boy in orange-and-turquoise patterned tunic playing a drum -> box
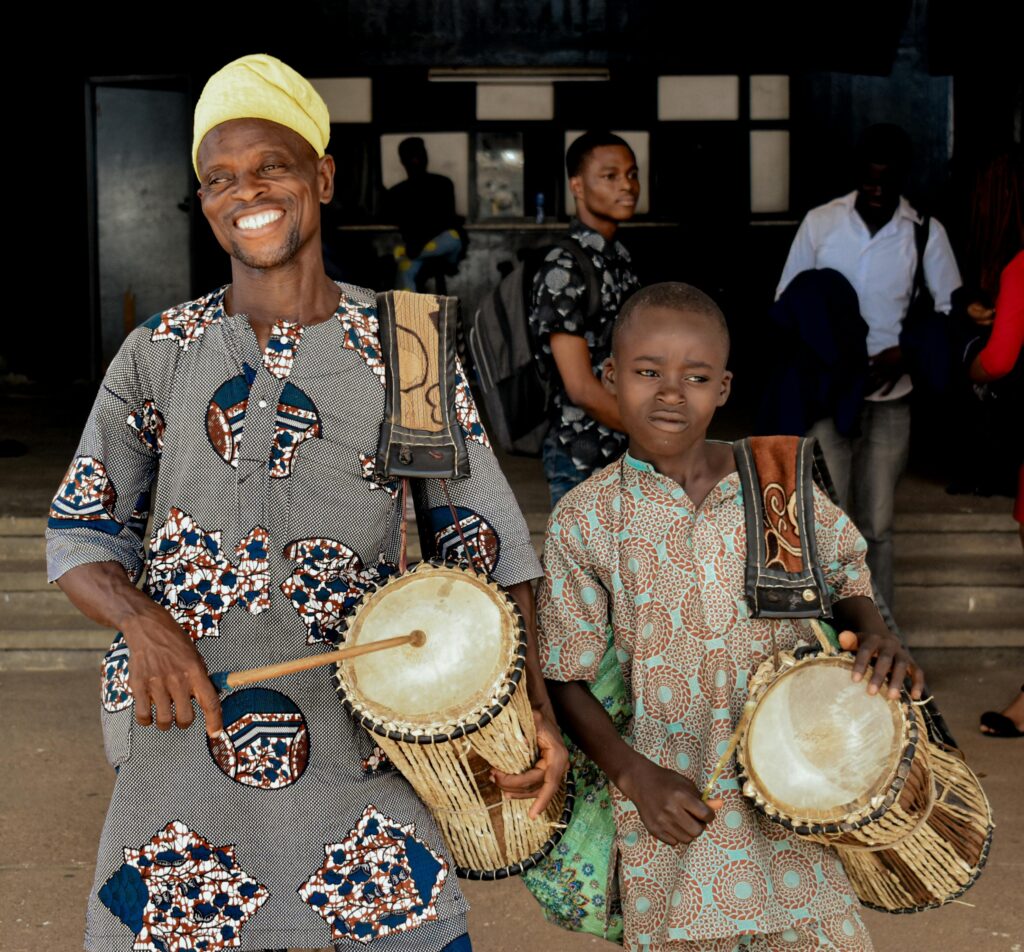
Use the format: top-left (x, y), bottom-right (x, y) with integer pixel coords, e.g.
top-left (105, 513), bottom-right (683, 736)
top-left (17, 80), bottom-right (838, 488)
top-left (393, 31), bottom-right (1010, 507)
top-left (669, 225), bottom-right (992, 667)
top-left (540, 284), bottom-right (924, 952)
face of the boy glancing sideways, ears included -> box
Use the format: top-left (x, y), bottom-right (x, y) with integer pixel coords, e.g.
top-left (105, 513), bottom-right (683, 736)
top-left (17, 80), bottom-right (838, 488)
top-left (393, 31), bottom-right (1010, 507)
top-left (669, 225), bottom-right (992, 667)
top-left (602, 307), bottom-right (732, 462)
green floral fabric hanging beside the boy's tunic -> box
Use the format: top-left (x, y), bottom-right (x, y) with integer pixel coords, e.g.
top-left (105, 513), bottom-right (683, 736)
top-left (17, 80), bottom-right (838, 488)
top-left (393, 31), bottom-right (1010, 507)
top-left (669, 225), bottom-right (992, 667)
top-left (523, 632), bottom-right (633, 944)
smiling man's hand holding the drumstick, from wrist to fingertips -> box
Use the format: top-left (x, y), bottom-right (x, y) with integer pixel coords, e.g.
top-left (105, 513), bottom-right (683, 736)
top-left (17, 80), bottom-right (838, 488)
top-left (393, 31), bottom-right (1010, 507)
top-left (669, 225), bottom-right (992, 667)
top-left (121, 602), bottom-right (223, 737)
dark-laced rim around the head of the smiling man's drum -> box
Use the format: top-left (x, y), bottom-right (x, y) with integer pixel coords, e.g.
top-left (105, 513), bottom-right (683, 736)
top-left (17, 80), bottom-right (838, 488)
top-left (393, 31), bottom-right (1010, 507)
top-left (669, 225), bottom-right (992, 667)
top-left (334, 559), bottom-right (527, 744)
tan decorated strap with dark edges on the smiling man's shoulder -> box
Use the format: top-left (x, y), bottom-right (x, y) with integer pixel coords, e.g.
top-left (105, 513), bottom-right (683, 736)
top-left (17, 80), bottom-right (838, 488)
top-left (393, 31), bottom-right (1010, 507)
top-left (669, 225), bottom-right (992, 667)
top-left (374, 291), bottom-right (469, 482)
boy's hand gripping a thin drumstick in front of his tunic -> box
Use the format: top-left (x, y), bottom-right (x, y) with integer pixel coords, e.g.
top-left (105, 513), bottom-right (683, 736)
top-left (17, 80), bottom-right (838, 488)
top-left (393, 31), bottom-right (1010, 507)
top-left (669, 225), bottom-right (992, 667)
top-left (620, 755), bottom-right (715, 847)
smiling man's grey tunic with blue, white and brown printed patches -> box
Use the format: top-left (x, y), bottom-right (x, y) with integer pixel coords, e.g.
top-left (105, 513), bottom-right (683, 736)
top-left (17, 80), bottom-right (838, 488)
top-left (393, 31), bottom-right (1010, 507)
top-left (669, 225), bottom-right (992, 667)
top-left (47, 286), bottom-right (540, 952)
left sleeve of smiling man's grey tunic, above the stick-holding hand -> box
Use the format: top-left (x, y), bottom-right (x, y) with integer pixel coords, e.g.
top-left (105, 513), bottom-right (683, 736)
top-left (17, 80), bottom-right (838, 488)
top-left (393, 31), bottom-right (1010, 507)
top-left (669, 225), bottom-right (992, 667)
top-left (46, 329), bottom-right (164, 581)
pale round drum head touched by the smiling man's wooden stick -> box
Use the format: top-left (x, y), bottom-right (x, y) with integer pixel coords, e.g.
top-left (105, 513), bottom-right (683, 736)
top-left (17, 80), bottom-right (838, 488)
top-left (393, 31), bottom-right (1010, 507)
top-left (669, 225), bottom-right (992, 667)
top-left (338, 564), bottom-right (519, 733)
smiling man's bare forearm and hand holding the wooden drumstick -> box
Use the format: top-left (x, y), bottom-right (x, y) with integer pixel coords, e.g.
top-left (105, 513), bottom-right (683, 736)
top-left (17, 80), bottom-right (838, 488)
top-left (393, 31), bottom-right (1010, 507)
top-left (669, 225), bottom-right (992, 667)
top-left (57, 562), bottom-right (223, 737)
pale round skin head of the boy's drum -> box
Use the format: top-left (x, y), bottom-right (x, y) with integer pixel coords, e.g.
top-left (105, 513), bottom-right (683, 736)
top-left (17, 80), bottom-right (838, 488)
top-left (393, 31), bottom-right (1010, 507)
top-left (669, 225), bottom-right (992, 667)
top-left (745, 658), bottom-right (903, 822)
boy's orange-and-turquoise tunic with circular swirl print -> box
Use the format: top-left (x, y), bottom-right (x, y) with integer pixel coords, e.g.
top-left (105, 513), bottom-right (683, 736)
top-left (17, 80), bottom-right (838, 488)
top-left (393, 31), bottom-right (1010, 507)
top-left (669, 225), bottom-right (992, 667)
top-left (539, 453), bottom-right (870, 949)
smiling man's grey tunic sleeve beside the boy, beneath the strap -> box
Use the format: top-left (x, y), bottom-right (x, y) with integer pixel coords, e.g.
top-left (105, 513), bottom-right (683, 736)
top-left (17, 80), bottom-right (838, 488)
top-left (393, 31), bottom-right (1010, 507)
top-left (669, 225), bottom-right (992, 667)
top-left (413, 361), bottom-right (542, 588)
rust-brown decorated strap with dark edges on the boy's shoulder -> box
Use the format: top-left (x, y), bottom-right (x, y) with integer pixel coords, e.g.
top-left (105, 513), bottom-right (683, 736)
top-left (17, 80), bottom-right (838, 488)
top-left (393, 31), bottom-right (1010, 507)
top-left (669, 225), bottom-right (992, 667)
top-left (733, 436), bottom-right (836, 618)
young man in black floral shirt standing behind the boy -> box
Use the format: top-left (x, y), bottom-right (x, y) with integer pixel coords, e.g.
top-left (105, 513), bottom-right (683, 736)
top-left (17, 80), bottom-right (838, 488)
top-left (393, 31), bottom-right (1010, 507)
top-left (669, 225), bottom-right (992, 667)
top-left (530, 132), bottom-right (640, 506)
